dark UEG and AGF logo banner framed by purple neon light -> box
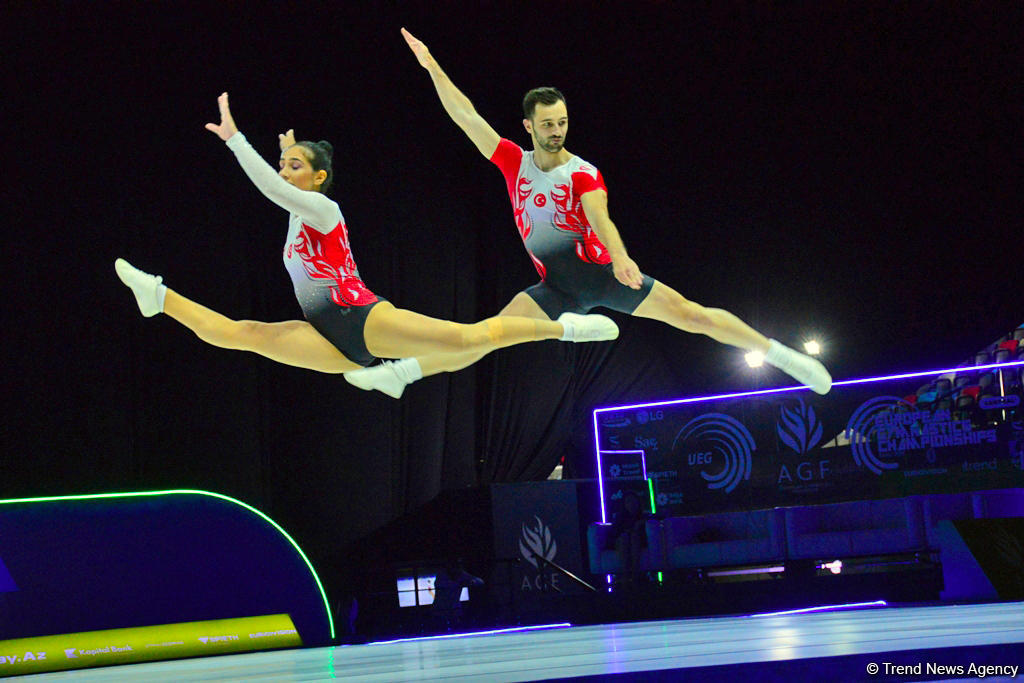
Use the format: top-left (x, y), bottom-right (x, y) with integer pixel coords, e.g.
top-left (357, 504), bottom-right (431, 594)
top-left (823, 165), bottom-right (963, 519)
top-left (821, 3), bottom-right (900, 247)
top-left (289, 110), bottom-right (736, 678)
top-left (594, 361), bottom-right (1024, 516)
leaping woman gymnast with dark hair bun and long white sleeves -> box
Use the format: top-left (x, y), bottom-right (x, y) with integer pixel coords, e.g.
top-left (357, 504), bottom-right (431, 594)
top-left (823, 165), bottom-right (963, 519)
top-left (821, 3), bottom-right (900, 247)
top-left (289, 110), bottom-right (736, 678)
top-left (114, 92), bottom-right (618, 381)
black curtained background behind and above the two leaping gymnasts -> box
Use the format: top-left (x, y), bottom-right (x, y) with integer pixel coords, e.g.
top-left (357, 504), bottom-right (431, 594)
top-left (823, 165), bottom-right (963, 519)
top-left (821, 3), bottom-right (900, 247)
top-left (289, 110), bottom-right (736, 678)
top-left (0, 2), bottom-right (1024, 602)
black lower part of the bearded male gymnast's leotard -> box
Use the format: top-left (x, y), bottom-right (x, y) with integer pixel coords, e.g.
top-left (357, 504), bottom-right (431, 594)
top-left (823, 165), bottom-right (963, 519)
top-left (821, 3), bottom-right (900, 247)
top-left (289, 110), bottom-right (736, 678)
top-left (523, 262), bottom-right (654, 319)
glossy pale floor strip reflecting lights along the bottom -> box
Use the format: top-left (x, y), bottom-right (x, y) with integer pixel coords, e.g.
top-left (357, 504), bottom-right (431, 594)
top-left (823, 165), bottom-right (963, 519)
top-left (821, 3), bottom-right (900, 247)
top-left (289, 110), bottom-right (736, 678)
top-left (26, 602), bottom-right (1024, 683)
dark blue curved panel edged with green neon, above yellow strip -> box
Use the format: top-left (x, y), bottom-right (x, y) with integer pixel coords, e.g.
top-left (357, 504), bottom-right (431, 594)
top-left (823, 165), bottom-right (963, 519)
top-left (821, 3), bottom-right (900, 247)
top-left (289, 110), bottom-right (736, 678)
top-left (0, 490), bottom-right (334, 645)
